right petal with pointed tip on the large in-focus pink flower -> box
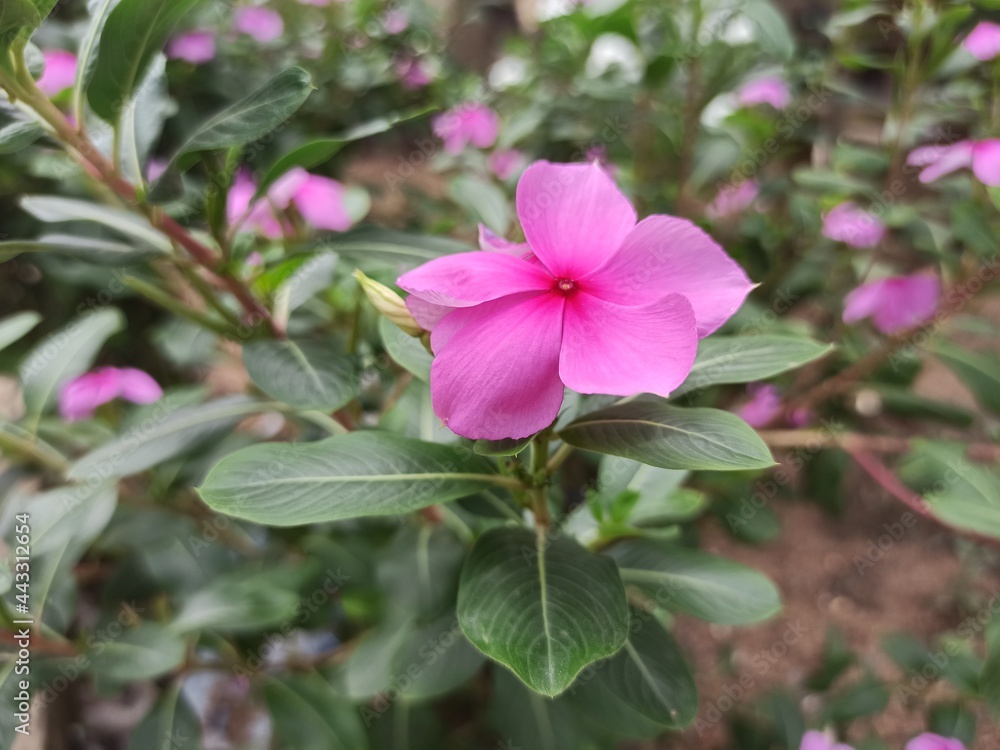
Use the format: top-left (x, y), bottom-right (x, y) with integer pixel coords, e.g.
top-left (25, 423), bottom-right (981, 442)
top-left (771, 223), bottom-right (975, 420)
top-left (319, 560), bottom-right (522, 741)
top-left (581, 216), bottom-right (754, 337)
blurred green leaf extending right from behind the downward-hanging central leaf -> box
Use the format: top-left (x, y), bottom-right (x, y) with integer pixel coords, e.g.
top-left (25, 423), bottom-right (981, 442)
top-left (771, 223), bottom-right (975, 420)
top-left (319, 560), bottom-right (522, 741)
top-left (609, 539), bottom-right (781, 625)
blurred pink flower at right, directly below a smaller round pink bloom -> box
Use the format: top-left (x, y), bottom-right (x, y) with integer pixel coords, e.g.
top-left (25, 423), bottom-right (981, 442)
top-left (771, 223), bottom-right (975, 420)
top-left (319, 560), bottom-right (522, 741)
top-left (844, 273), bottom-right (941, 333)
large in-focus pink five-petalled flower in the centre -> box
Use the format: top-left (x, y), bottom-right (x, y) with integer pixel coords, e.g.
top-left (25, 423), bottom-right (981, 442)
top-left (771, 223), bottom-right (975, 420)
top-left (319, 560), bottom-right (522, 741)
top-left (397, 161), bottom-right (753, 439)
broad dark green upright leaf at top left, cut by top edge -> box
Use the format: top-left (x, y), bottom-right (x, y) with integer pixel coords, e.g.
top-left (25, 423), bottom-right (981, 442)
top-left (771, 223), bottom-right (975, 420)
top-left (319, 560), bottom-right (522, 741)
top-left (87, 0), bottom-right (206, 123)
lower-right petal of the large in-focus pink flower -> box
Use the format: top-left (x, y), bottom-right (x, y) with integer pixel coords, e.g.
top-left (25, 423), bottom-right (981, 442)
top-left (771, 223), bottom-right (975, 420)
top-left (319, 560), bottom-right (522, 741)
top-left (559, 292), bottom-right (698, 396)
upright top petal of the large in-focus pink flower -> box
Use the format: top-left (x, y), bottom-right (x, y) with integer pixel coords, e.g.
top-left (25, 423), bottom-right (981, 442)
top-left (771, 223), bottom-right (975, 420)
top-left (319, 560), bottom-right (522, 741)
top-left (517, 161), bottom-right (636, 279)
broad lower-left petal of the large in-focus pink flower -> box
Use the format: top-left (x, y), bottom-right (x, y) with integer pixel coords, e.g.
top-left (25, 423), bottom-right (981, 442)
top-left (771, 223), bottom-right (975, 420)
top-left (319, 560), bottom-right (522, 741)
top-left (431, 294), bottom-right (565, 440)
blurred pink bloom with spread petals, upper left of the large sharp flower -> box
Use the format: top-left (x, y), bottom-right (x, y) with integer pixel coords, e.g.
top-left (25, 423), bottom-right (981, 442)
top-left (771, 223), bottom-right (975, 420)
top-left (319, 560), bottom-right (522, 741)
top-left (226, 168), bottom-right (353, 239)
